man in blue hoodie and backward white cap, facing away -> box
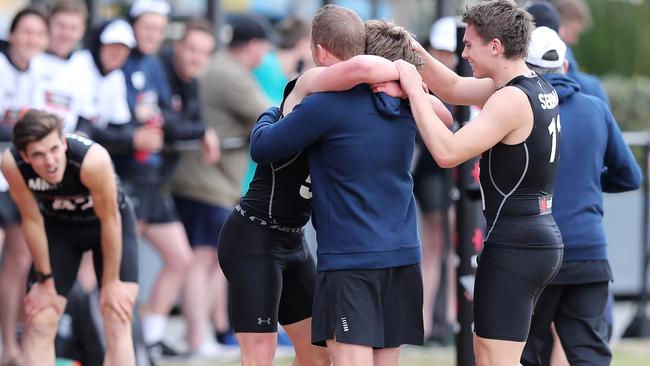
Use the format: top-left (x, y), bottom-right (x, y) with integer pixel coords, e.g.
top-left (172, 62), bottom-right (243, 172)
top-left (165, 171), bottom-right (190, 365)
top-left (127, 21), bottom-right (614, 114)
top-left (522, 27), bottom-right (641, 366)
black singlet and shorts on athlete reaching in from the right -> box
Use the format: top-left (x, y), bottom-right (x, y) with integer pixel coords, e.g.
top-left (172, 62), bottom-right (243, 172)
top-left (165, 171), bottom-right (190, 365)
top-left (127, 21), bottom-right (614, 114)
top-left (474, 76), bottom-right (563, 342)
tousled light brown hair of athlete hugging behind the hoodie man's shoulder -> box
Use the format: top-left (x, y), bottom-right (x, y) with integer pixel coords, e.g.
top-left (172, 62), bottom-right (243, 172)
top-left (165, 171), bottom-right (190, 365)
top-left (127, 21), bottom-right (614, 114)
top-left (365, 19), bottom-right (424, 69)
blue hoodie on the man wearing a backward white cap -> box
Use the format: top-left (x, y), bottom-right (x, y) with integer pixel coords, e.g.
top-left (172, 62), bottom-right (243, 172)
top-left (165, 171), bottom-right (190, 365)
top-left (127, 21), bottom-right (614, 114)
top-left (544, 74), bottom-right (641, 262)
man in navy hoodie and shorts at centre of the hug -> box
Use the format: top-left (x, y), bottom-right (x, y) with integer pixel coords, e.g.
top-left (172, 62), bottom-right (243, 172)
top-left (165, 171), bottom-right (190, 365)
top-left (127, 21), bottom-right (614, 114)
top-left (250, 12), bottom-right (423, 365)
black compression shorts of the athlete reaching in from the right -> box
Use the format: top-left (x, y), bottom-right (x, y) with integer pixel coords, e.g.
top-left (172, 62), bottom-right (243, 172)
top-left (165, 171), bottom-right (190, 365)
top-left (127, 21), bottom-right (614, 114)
top-left (474, 243), bottom-right (563, 342)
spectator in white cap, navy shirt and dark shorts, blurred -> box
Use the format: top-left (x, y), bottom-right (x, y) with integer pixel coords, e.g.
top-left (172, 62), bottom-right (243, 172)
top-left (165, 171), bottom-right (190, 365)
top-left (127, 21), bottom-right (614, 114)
top-left (120, 0), bottom-right (192, 356)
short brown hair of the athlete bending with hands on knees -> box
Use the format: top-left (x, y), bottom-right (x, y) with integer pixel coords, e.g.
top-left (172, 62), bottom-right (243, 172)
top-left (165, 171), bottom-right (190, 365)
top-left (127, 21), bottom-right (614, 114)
top-left (12, 109), bottom-right (63, 151)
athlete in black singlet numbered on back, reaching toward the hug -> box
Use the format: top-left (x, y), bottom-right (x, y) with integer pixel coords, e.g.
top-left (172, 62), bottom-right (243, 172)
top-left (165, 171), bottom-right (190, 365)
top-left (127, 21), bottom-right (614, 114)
top-left (397, 0), bottom-right (563, 366)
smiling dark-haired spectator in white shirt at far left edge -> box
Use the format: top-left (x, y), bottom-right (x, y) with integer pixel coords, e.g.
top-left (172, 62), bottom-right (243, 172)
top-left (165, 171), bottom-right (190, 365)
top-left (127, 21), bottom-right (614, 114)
top-left (0, 8), bottom-right (48, 365)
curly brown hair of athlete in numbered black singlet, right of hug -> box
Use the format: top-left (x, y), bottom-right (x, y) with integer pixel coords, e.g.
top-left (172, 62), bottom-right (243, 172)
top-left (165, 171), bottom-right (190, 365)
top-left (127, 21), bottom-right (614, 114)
top-left (463, 0), bottom-right (535, 59)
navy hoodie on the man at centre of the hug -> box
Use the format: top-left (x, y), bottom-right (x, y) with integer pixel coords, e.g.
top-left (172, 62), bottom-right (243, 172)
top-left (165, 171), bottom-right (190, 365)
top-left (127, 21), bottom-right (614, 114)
top-left (250, 84), bottom-right (420, 271)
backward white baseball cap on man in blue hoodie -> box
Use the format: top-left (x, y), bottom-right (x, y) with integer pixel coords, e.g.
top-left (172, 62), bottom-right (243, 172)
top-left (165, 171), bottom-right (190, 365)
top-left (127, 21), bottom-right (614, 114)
top-left (526, 27), bottom-right (566, 69)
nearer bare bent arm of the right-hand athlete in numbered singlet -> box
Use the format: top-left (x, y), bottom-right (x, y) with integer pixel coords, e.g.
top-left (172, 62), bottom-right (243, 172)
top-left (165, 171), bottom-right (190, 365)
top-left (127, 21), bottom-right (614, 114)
top-left (398, 63), bottom-right (532, 168)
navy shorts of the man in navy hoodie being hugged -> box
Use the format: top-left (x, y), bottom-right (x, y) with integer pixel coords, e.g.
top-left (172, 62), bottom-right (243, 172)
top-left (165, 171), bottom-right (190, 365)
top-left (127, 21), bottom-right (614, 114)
top-left (311, 264), bottom-right (424, 349)
